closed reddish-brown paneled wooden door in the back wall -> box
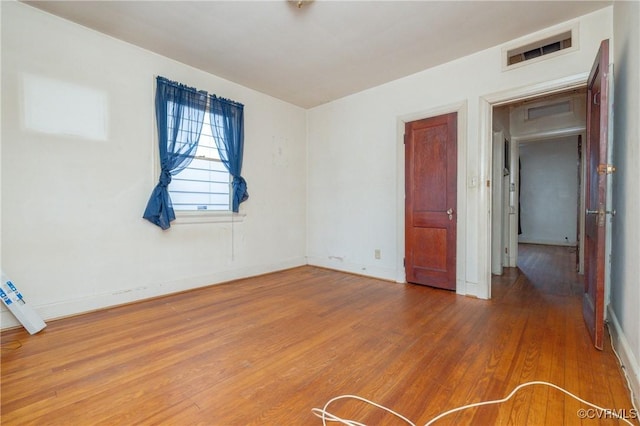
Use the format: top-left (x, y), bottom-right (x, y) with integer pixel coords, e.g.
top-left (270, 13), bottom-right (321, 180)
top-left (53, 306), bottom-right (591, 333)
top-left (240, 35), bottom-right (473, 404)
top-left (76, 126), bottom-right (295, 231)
top-left (405, 113), bottom-right (457, 290)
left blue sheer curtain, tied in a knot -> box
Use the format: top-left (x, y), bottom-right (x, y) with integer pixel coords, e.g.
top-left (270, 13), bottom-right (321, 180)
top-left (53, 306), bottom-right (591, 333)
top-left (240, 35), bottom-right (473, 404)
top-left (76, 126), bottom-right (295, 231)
top-left (142, 77), bottom-right (207, 229)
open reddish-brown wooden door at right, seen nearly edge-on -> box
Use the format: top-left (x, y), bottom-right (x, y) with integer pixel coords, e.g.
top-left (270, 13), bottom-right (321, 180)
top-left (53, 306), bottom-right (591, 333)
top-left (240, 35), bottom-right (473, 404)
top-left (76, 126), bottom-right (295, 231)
top-left (582, 40), bottom-right (612, 349)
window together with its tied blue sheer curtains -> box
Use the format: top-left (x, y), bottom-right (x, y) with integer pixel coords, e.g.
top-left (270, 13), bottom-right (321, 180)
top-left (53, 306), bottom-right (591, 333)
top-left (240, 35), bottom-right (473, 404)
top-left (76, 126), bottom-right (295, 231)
top-left (142, 76), bottom-right (249, 230)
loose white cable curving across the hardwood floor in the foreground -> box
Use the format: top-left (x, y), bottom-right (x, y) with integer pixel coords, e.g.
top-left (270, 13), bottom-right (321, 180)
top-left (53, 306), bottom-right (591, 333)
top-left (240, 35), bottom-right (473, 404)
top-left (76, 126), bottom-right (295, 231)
top-left (311, 381), bottom-right (637, 426)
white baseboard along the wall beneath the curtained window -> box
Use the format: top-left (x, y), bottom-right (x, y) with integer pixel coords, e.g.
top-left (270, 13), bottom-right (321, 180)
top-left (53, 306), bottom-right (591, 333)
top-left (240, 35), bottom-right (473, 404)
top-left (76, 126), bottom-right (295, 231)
top-left (0, 257), bottom-right (306, 329)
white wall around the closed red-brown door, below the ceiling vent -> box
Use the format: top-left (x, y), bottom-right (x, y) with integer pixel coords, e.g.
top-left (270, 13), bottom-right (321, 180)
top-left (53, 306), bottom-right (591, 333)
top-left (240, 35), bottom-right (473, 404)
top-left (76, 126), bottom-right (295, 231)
top-left (307, 8), bottom-right (612, 297)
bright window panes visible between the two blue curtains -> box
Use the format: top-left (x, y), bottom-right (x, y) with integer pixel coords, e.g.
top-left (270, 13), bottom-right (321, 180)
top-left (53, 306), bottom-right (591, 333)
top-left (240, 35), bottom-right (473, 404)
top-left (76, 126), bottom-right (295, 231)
top-left (169, 110), bottom-right (231, 211)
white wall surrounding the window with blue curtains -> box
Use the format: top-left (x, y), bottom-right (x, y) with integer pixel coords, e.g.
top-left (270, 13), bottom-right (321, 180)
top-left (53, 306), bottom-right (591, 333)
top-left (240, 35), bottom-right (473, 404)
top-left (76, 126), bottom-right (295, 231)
top-left (0, 2), bottom-right (306, 327)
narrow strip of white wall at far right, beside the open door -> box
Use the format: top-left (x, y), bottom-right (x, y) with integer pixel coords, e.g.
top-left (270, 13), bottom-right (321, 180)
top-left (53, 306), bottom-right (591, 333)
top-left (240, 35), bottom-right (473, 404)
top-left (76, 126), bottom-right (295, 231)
top-left (608, 1), bottom-right (640, 406)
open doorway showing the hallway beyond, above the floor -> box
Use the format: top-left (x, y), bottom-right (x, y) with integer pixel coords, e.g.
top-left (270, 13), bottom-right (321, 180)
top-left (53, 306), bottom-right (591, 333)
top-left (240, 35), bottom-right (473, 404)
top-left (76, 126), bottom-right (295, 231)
top-left (490, 87), bottom-right (586, 288)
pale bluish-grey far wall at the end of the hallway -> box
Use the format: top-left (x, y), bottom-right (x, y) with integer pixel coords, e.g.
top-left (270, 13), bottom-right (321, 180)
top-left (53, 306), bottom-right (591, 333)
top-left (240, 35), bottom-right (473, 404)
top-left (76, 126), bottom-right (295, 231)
top-left (518, 136), bottom-right (579, 246)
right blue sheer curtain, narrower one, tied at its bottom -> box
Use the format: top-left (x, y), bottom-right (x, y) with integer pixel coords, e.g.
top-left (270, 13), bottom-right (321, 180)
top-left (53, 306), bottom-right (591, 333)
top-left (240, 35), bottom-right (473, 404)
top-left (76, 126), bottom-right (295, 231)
top-left (209, 95), bottom-right (249, 213)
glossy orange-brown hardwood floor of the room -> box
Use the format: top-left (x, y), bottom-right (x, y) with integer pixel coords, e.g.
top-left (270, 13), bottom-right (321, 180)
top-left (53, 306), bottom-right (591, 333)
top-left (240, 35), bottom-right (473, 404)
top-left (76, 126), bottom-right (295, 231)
top-left (1, 248), bottom-right (633, 425)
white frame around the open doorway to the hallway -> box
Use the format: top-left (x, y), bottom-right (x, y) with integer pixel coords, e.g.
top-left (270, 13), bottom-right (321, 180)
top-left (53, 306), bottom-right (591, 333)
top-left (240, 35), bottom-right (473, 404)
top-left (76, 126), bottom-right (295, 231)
top-left (478, 72), bottom-right (592, 299)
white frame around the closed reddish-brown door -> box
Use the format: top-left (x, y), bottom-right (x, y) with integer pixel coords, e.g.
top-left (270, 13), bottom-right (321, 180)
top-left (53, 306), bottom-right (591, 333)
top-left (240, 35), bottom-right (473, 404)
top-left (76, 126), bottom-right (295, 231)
top-left (396, 100), bottom-right (467, 294)
